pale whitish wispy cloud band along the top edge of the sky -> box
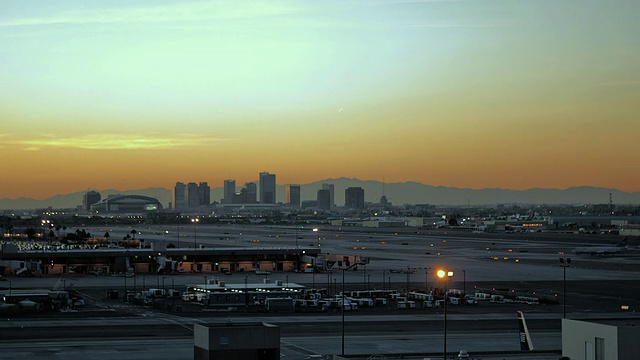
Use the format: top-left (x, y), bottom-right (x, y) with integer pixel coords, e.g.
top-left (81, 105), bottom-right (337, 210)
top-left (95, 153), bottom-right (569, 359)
top-left (0, 0), bottom-right (512, 30)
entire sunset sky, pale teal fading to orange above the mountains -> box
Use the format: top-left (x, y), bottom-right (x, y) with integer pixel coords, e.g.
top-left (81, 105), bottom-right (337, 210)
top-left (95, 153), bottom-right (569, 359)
top-left (0, 0), bottom-right (640, 198)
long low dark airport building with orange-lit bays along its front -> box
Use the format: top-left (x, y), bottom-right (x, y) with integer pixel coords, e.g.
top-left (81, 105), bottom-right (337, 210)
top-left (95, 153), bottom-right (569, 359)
top-left (0, 244), bottom-right (320, 275)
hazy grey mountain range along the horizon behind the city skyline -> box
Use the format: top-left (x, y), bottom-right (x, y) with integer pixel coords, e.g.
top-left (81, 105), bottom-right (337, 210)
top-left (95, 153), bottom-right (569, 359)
top-left (0, 178), bottom-right (640, 210)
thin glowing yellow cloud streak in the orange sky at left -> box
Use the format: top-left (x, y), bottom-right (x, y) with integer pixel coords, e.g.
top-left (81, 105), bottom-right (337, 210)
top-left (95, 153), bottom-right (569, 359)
top-left (13, 134), bottom-right (228, 151)
